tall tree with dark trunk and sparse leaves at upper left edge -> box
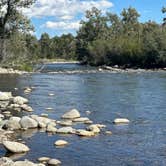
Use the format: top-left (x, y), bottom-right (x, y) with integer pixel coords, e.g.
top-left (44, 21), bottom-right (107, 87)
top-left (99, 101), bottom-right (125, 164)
top-left (0, 0), bottom-right (35, 60)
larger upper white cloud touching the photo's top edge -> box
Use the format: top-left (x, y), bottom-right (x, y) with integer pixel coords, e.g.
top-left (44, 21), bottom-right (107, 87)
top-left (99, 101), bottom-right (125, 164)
top-left (23, 0), bottom-right (113, 19)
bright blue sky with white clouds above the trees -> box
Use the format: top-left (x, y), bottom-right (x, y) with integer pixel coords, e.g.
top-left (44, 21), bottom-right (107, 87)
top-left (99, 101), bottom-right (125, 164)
top-left (23, 0), bottom-right (166, 38)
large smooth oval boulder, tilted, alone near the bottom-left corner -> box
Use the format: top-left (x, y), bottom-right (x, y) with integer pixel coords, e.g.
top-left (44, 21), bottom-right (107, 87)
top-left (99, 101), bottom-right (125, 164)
top-left (3, 141), bottom-right (30, 153)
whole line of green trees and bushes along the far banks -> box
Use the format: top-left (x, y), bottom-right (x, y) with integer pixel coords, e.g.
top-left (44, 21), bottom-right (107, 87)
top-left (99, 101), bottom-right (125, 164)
top-left (0, 0), bottom-right (166, 70)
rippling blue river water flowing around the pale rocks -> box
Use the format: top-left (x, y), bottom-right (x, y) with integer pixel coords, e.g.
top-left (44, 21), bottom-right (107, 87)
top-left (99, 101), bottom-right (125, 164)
top-left (0, 64), bottom-right (166, 166)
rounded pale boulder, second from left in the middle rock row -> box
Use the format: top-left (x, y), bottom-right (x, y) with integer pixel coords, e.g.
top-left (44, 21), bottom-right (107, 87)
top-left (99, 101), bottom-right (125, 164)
top-left (20, 116), bottom-right (38, 129)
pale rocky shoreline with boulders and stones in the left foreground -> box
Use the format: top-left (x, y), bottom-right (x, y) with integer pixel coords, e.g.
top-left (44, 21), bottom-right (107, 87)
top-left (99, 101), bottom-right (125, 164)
top-left (0, 91), bottom-right (130, 166)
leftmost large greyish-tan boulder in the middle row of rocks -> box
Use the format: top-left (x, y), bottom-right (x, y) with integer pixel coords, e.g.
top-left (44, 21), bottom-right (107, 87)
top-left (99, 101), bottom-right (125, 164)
top-left (4, 117), bottom-right (21, 130)
